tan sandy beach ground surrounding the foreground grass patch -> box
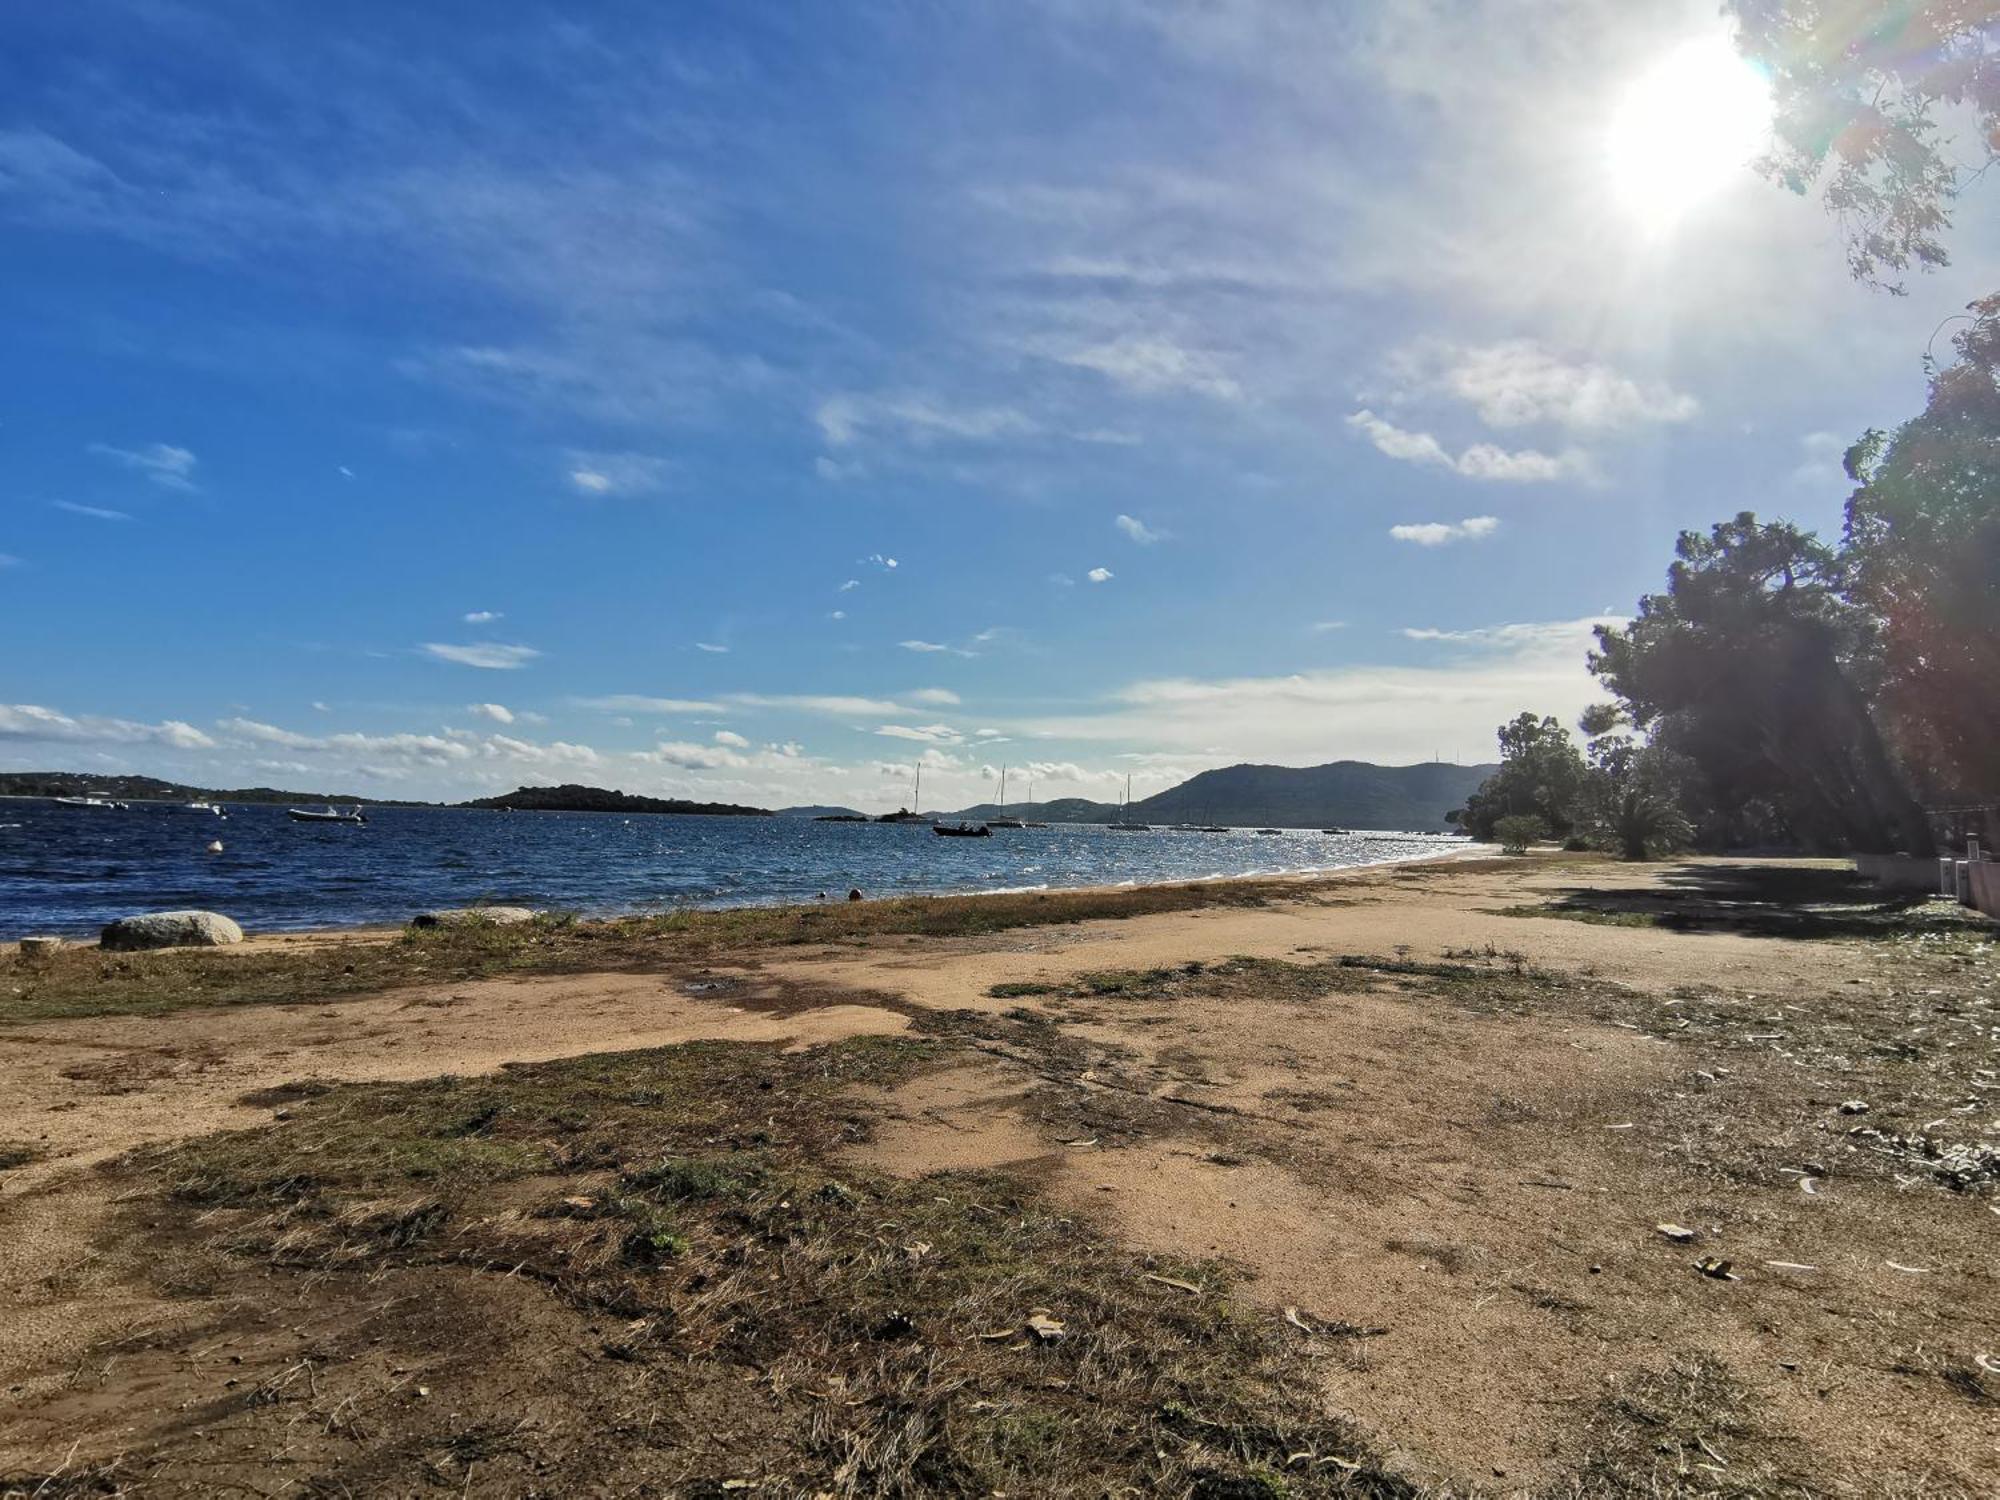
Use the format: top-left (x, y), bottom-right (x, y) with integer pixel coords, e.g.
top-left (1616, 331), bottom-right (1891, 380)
top-left (0, 858), bottom-right (2000, 1494)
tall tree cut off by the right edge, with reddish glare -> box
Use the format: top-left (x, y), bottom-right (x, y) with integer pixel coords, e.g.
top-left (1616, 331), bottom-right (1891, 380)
top-left (1842, 286), bottom-right (2000, 800)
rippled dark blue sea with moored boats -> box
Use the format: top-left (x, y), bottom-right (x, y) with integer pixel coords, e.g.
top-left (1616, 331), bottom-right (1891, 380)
top-left (0, 798), bottom-right (1462, 938)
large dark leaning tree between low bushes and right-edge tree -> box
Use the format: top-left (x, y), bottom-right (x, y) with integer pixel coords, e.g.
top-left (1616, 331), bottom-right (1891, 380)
top-left (1590, 512), bottom-right (1932, 852)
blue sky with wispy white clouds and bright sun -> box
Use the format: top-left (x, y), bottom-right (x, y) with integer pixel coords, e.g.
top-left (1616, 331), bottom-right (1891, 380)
top-left (0, 0), bottom-right (2000, 810)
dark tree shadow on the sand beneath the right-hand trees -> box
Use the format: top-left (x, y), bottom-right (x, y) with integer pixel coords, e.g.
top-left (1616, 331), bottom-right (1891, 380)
top-left (1510, 864), bottom-right (1976, 940)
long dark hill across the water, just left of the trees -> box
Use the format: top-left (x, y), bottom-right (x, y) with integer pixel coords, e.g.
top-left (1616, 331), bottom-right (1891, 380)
top-left (1132, 760), bottom-right (1498, 832)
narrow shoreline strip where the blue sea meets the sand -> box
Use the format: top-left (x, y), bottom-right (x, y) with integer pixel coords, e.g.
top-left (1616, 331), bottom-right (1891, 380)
top-left (0, 840), bottom-right (1500, 952)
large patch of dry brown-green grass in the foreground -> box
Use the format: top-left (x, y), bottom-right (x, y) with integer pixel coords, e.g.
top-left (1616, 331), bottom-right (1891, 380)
top-left (58, 1040), bottom-right (1408, 1498)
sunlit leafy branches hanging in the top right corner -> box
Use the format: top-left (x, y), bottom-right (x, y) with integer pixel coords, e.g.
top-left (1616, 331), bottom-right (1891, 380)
top-left (1724, 0), bottom-right (2000, 294)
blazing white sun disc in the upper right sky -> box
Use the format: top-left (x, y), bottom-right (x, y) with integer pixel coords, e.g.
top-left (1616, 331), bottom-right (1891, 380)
top-left (1606, 36), bottom-right (1772, 230)
